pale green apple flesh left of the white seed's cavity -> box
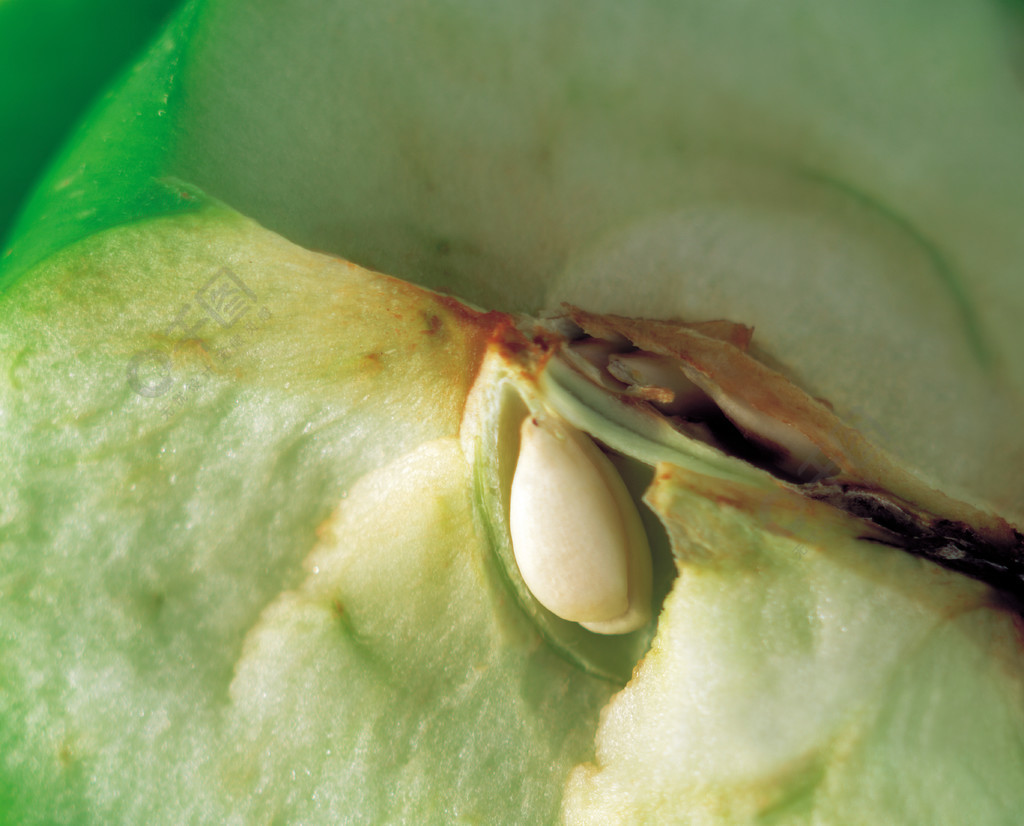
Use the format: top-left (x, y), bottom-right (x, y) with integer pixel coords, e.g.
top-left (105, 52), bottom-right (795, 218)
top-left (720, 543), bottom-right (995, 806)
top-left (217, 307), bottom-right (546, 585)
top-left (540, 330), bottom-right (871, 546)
top-left (0, 210), bottom-right (614, 824)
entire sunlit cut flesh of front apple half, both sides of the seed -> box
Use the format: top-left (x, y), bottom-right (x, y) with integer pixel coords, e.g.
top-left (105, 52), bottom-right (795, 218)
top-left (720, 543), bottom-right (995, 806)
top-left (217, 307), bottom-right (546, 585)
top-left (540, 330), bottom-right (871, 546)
top-left (0, 208), bottom-right (1024, 824)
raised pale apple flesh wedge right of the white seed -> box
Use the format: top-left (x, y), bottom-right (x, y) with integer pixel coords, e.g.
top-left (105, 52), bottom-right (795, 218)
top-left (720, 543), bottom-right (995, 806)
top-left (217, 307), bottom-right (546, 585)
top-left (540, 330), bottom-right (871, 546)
top-left (565, 468), bottom-right (1024, 826)
